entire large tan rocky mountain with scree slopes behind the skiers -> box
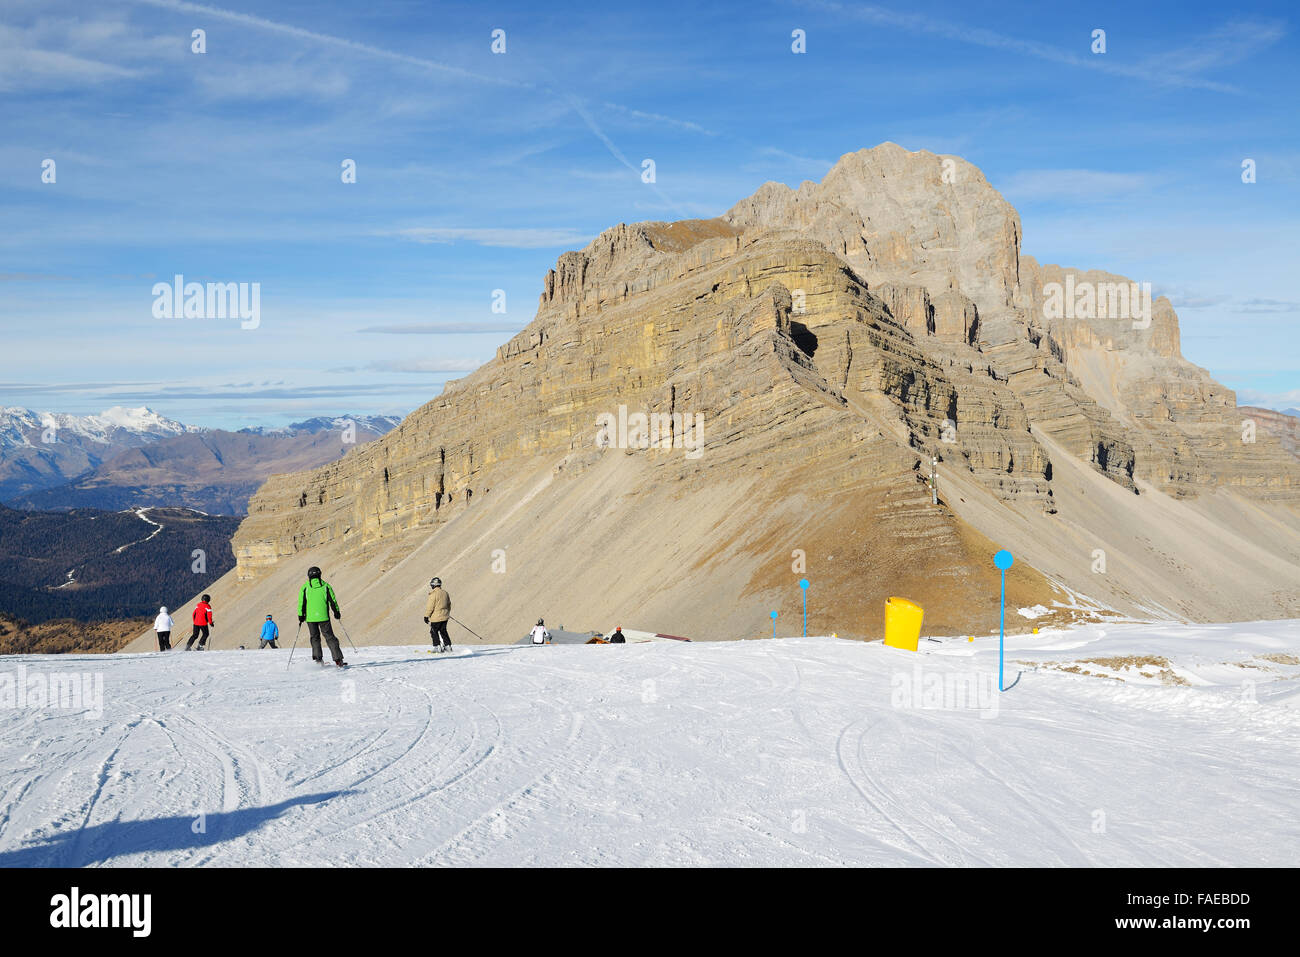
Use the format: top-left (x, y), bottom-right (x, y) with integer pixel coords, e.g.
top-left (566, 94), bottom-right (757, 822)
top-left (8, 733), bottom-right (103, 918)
top-left (124, 143), bottom-right (1300, 644)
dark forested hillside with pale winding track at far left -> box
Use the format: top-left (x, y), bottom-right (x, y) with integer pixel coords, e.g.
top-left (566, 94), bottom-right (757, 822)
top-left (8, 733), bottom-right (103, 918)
top-left (0, 506), bottom-right (239, 624)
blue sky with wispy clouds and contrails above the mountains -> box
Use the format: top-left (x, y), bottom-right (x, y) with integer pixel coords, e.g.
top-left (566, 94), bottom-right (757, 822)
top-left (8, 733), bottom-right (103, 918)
top-left (0, 0), bottom-right (1300, 428)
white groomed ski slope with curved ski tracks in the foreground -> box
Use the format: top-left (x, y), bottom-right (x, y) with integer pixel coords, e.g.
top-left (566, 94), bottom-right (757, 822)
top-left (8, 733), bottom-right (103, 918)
top-left (0, 620), bottom-right (1300, 867)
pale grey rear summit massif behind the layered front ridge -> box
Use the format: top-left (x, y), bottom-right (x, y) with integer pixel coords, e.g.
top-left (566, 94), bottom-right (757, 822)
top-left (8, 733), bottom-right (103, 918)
top-left (724, 143), bottom-right (1297, 501)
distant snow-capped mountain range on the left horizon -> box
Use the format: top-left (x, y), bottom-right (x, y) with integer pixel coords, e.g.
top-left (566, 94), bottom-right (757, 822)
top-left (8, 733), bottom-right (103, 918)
top-left (0, 407), bottom-right (400, 515)
